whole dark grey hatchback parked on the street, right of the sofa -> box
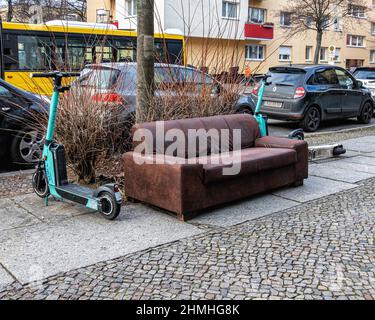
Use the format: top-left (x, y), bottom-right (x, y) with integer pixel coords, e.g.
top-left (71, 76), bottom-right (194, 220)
top-left (252, 65), bottom-right (374, 132)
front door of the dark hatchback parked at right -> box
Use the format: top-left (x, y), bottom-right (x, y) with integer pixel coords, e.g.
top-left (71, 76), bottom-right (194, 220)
top-left (335, 68), bottom-right (363, 116)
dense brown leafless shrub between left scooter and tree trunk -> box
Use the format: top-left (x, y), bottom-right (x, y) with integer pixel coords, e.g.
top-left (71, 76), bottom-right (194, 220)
top-left (56, 87), bottom-right (129, 182)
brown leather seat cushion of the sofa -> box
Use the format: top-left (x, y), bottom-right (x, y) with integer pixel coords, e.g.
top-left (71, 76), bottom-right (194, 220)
top-left (204, 148), bottom-right (297, 183)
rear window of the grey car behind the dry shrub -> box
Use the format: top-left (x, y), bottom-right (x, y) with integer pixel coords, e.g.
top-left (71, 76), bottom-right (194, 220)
top-left (78, 67), bottom-right (120, 89)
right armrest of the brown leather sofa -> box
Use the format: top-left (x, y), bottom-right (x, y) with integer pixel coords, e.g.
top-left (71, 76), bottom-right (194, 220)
top-left (255, 136), bottom-right (309, 181)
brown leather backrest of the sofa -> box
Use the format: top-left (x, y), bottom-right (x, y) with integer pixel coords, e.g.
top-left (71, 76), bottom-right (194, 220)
top-left (132, 114), bottom-right (261, 158)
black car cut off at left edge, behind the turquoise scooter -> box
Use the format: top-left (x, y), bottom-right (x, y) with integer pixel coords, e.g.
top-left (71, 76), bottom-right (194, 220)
top-left (0, 79), bottom-right (48, 164)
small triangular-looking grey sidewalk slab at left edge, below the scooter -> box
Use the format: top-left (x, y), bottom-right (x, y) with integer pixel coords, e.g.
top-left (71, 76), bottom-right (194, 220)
top-left (0, 199), bottom-right (40, 231)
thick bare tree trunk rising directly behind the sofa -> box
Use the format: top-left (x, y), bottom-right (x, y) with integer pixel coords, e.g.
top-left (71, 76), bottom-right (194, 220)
top-left (136, 0), bottom-right (154, 122)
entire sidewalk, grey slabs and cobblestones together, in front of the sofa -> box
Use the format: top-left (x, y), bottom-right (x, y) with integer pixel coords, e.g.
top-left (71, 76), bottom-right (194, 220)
top-left (0, 136), bottom-right (375, 299)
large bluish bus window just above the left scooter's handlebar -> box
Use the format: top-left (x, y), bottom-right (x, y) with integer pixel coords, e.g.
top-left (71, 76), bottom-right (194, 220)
top-left (18, 35), bottom-right (51, 70)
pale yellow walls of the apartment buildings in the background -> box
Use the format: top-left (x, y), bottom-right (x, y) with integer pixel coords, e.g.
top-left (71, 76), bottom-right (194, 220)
top-left (87, 0), bottom-right (375, 73)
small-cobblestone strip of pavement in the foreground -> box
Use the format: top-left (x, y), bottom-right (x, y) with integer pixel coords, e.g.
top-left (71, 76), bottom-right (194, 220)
top-left (0, 179), bottom-right (375, 299)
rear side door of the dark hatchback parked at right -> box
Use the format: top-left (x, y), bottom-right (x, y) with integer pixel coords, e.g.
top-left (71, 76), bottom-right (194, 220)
top-left (308, 68), bottom-right (341, 119)
